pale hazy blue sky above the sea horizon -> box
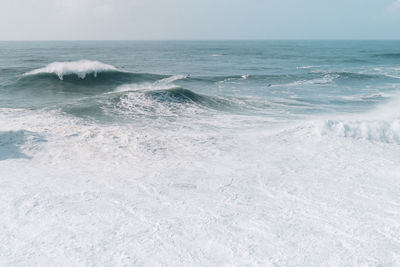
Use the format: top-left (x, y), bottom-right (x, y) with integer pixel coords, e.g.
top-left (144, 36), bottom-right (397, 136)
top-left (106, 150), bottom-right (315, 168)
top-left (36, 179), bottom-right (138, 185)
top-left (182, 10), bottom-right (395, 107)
top-left (0, 0), bottom-right (400, 40)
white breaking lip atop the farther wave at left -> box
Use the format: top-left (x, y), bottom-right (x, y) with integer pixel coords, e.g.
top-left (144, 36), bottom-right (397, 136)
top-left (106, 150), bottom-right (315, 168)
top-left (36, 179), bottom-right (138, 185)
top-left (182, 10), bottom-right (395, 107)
top-left (24, 60), bottom-right (120, 80)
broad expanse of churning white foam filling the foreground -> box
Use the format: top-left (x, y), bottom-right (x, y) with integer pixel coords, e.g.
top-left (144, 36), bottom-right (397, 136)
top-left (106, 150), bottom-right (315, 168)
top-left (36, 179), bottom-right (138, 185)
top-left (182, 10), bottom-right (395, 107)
top-left (0, 102), bottom-right (400, 266)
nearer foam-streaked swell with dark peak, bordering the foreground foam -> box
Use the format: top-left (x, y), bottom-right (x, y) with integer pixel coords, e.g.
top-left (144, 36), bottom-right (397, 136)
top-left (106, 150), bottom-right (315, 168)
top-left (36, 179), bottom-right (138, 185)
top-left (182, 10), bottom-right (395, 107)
top-left (61, 87), bottom-right (240, 121)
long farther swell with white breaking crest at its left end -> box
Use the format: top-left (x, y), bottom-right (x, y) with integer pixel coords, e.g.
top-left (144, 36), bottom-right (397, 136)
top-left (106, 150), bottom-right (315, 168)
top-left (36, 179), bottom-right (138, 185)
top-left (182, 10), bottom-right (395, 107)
top-left (10, 61), bottom-right (398, 96)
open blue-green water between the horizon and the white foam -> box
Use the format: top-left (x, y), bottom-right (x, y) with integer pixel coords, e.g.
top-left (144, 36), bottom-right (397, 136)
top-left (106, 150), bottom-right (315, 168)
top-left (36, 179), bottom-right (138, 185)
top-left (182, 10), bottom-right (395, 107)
top-left (0, 41), bottom-right (400, 120)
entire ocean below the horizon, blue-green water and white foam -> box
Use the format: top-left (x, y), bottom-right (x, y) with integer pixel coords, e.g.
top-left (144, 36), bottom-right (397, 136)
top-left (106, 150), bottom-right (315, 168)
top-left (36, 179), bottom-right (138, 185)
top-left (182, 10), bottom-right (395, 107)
top-left (0, 41), bottom-right (400, 266)
